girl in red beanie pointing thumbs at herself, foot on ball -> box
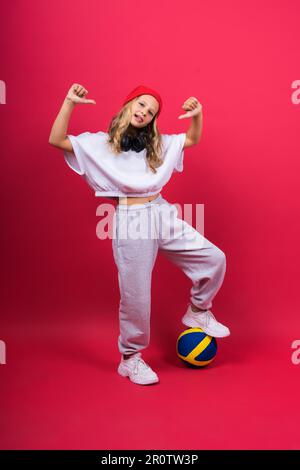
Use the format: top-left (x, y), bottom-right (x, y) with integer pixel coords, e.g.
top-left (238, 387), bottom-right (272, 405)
top-left (49, 83), bottom-right (230, 385)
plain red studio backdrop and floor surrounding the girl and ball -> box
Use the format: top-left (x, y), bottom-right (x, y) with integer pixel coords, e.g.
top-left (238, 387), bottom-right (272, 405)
top-left (0, 0), bottom-right (300, 449)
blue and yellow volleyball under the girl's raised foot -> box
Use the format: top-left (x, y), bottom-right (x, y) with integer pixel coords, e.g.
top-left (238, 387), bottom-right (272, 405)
top-left (176, 328), bottom-right (217, 367)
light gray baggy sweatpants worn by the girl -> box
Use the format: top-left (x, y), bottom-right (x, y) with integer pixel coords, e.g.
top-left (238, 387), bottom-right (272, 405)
top-left (112, 194), bottom-right (226, 354)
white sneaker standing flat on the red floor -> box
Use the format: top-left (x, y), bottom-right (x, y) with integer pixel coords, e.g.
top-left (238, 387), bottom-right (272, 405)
top-left (118, 353), bottom-right (159, 385)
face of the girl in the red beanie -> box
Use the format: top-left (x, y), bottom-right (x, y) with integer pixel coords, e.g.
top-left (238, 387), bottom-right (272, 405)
top-left (131, 95), bottom-right (159, 129)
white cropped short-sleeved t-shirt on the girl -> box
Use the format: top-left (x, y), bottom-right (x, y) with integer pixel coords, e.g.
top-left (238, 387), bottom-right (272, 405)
top-left (63, 131), bottom-right (186, 197)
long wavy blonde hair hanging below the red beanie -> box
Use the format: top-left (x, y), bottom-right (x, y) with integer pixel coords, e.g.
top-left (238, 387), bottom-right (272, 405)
top-left (108, 97), bottom-right (163, 173)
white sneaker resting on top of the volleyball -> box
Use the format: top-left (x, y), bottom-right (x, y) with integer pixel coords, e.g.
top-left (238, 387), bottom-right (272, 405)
top-left (181, 304), bottom-right (230, 338)
